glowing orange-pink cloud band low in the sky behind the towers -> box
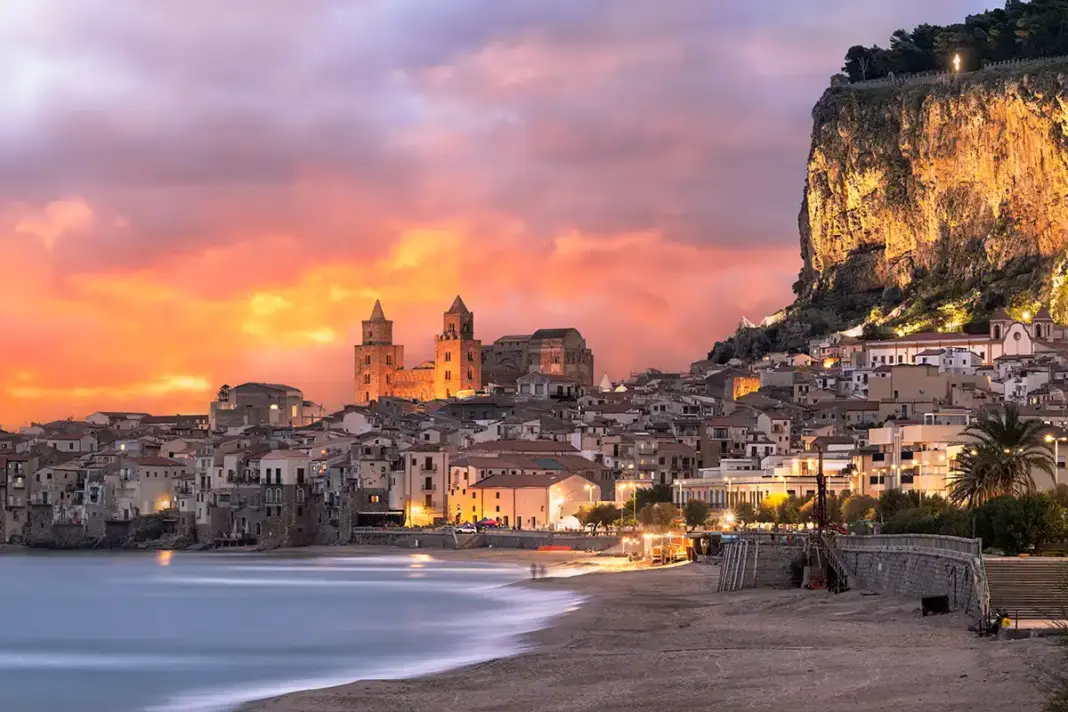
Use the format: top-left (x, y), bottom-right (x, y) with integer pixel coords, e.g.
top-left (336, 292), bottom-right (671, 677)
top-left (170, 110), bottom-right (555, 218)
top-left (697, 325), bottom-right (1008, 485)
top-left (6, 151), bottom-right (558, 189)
top-left (0, 195), bottom-right (797, 427)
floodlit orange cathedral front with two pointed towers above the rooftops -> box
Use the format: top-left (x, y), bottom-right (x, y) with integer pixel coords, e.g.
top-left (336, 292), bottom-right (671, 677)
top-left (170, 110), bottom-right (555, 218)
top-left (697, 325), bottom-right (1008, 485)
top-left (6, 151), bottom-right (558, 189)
top-left (356, 296), bottom-right (482, 405)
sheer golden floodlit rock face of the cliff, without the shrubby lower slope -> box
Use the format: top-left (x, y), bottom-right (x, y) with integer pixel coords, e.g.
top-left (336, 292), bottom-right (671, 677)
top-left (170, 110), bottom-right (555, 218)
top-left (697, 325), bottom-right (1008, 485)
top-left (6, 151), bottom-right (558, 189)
top-left (799, 66), bottom-right (1068, 315)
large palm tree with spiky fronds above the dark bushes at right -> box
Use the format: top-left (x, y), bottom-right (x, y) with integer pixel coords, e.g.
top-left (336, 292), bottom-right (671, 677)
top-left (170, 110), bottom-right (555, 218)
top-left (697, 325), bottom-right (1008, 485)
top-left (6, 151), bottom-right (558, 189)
top-left (949, 404), bottom-right (1055, 507)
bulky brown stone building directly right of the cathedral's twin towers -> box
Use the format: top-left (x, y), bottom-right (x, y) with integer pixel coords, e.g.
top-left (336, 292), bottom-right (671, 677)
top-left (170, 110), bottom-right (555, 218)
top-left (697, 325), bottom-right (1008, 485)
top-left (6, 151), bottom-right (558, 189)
top-left (482, 327), bottom-right (594, 387)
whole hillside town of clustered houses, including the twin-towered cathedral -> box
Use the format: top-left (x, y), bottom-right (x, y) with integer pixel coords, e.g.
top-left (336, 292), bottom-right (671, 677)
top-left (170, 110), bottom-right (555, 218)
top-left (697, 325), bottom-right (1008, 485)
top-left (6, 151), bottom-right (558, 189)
top-left (0, 297), bottom-right (1068, 548)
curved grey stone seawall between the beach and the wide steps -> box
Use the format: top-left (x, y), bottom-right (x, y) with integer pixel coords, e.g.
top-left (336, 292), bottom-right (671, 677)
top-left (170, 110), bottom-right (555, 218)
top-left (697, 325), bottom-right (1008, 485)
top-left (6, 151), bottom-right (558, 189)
top-left (839, 541), bottom-right (987, 616)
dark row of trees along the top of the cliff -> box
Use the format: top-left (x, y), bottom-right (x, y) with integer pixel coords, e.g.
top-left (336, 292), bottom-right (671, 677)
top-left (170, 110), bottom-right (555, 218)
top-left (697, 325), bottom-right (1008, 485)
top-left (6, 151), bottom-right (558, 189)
top-left (842, 0), bottom-right (1068, 81)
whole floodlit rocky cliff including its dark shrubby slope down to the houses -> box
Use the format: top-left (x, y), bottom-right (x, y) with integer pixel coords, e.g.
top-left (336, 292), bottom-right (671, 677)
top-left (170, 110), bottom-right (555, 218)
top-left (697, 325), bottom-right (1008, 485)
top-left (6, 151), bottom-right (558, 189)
top-left (709, 60), bottom-right (1068, 362)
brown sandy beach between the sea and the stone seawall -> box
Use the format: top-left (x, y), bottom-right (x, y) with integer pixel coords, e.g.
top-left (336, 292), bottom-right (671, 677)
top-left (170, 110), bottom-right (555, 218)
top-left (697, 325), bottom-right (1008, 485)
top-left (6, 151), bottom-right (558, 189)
top-left (245, 549), bottom-right (1056, 712)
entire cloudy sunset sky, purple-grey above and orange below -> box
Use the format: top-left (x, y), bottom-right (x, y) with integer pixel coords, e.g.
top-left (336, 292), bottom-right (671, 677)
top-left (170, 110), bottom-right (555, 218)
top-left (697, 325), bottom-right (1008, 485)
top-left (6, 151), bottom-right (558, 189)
top-left (0, 0), bottom-right (995, 429)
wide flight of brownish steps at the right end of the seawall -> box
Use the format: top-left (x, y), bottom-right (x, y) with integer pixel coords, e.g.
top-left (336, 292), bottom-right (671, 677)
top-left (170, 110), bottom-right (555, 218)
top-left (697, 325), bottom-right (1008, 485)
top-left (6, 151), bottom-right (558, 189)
top-left (985, 557), bottom-right (1068, 620)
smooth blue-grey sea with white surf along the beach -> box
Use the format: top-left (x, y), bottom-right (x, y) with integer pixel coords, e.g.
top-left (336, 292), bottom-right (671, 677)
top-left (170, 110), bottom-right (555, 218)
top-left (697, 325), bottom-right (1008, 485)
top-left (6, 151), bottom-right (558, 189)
top-left (0, 553), bottom-right (578, 712)
